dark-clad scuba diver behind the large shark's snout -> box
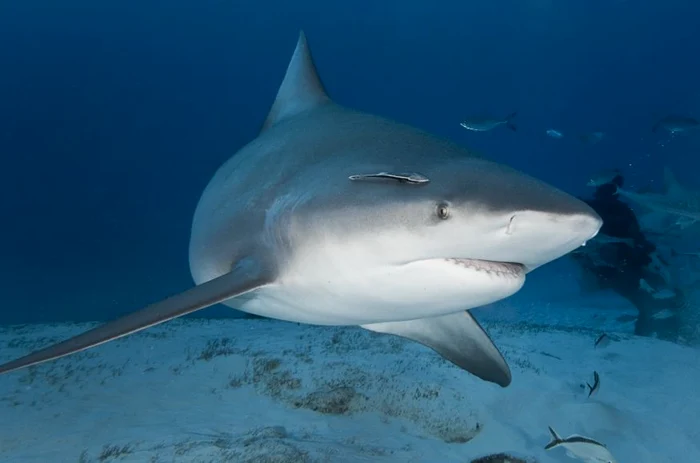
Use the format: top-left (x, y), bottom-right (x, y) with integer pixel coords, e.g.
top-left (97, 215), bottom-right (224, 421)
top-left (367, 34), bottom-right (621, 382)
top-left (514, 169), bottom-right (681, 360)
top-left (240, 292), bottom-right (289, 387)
top-left (572, 174), bottom-right (685, 341)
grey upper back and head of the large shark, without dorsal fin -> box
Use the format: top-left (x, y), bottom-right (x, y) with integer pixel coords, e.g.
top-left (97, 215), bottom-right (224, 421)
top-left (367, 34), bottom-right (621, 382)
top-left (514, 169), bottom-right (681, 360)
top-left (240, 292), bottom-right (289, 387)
top-left (190, 100), bottom-right (584, 283)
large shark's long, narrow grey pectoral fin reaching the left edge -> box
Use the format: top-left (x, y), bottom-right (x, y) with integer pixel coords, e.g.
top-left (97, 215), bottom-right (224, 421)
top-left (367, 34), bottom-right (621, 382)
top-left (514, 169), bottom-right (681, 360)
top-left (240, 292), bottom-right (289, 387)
top-left (0, 260), bottom-right (270, 374)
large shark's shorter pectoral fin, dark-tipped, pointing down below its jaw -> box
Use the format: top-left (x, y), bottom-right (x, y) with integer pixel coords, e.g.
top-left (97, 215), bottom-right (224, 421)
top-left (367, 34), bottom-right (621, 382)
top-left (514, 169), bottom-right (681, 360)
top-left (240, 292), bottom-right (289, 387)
top-left (362, 311), bottom-right (511, 387)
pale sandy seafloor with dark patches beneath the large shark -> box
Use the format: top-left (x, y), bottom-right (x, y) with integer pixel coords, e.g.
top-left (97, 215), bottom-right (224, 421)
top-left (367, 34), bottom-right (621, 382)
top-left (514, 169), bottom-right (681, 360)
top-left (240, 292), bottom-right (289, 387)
top-left (0, 304), bottom-right (700, 463)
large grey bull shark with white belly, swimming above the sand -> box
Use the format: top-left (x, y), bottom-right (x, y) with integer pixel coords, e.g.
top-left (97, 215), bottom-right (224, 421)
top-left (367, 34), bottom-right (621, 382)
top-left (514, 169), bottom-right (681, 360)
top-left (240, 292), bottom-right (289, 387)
top-left (0, 31), bottom-right (602, 387)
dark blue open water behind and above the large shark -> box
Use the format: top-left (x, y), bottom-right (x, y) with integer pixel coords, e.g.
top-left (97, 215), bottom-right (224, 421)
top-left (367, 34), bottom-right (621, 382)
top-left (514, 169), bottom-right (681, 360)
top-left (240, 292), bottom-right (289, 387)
top-left (0, 0), bottom-right (700, 323)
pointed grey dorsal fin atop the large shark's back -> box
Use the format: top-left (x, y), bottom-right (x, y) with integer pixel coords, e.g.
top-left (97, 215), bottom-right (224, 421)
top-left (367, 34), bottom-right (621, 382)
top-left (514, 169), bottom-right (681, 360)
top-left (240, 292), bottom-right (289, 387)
top-left (262, 31), bottom-right (330, 131)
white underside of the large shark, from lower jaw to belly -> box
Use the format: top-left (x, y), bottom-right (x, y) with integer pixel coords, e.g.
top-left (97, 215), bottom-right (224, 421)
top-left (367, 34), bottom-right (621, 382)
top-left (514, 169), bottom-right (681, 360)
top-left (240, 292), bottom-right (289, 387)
top-left (226, 259), bottom-right (525, 325)
